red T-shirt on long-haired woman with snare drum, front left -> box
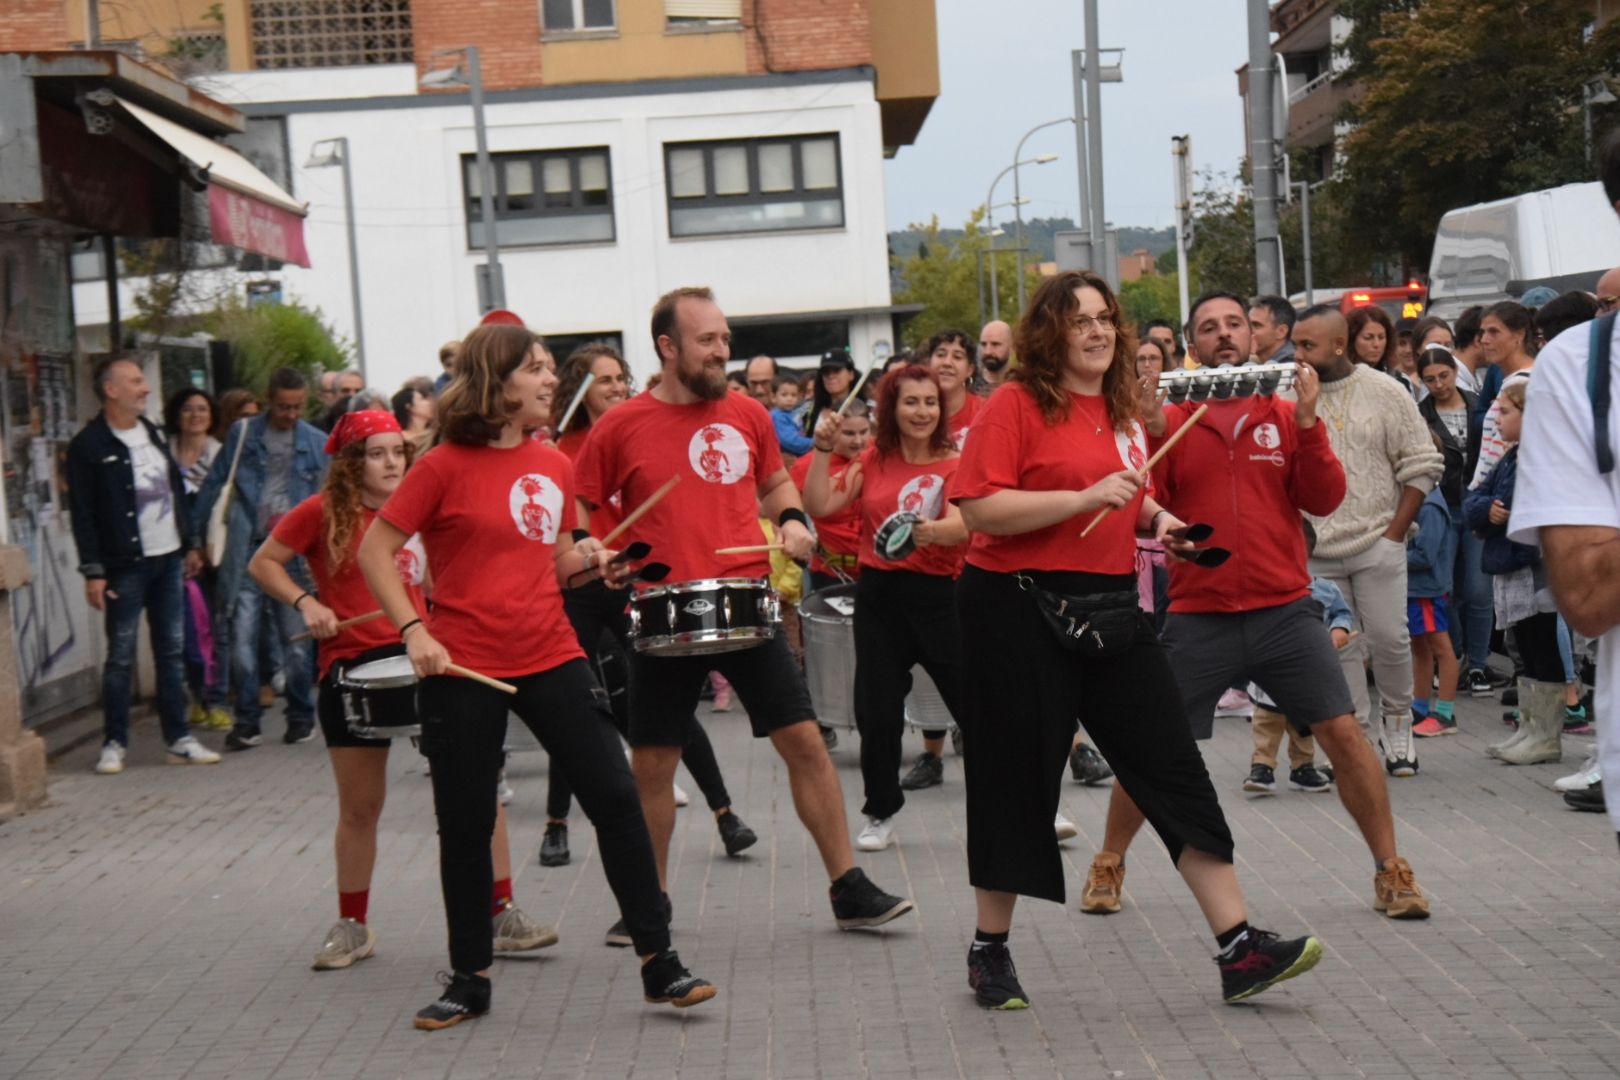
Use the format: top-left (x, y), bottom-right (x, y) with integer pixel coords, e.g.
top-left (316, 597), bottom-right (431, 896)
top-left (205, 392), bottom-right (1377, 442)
top-left (379, 439), bottom-right (585, 675)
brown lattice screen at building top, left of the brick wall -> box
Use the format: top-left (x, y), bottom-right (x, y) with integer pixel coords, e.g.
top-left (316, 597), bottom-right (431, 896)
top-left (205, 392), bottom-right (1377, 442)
top-left (248, 0), bottom-right (416, 68)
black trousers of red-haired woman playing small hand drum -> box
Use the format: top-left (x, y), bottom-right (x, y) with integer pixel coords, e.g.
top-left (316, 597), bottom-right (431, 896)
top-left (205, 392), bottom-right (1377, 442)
top-left (855, 567), bottom-right (962, 818)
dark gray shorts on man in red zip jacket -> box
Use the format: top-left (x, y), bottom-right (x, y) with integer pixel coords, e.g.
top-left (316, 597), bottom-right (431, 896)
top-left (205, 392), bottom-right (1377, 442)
top-left (1165, 596), bottom-right (1356, 738)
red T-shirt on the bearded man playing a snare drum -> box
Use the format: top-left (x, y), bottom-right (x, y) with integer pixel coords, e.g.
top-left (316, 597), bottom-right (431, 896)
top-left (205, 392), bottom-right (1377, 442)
top-left (578, 393), bottom-right (782, 583)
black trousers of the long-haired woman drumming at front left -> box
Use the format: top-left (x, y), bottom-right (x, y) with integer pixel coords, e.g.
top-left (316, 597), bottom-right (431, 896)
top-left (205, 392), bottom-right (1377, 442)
top-left (420, 661), bottom-right (669, 975)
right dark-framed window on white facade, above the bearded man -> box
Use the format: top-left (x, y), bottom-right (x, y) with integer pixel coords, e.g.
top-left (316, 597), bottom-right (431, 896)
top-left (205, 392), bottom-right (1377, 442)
top-left (664, 134), bottom-right (844, 236)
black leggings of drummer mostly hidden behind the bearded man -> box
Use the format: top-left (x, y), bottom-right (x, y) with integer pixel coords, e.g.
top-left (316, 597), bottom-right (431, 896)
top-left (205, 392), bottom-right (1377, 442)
top-left (546, 581), bottom-right (731, 821)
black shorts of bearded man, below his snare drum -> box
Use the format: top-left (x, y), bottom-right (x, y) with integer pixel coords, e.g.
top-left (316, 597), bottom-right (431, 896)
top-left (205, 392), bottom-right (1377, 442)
top-left (630, 631), bottom-right (815, 746)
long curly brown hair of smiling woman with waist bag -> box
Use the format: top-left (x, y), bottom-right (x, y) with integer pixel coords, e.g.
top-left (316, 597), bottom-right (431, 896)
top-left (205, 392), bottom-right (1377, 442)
top-left (1008, 270), bottom-right (1140, 431)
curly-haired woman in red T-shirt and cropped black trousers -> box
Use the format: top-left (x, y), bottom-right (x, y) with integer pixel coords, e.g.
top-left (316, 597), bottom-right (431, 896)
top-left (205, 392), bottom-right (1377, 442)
top-left (951, 270), bottom-right (1320, 1009)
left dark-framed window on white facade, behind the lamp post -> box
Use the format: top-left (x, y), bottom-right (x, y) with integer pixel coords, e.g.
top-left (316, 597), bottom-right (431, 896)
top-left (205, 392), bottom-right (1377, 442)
top-left (462, 146), bottom-right (614, 248)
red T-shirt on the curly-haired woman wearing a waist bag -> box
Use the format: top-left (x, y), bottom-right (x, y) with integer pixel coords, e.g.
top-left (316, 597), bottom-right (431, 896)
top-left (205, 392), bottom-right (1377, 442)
top-left (949, 385), bottom-right (1147, 573)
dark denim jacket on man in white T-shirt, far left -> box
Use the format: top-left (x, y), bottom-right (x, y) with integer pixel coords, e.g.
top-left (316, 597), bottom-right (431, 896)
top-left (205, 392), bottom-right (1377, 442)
top-left (68, 413), bottom-right (203, 578)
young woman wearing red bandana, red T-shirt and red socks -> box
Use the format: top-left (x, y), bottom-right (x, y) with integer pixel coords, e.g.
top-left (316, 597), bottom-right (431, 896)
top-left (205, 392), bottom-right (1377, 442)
top-left (248, 410), bottom-right (557, 972)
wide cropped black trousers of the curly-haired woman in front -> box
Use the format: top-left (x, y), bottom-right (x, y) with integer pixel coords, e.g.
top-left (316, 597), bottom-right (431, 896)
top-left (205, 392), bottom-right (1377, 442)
top-left (952, 565), bottom-right (1231, 904)
